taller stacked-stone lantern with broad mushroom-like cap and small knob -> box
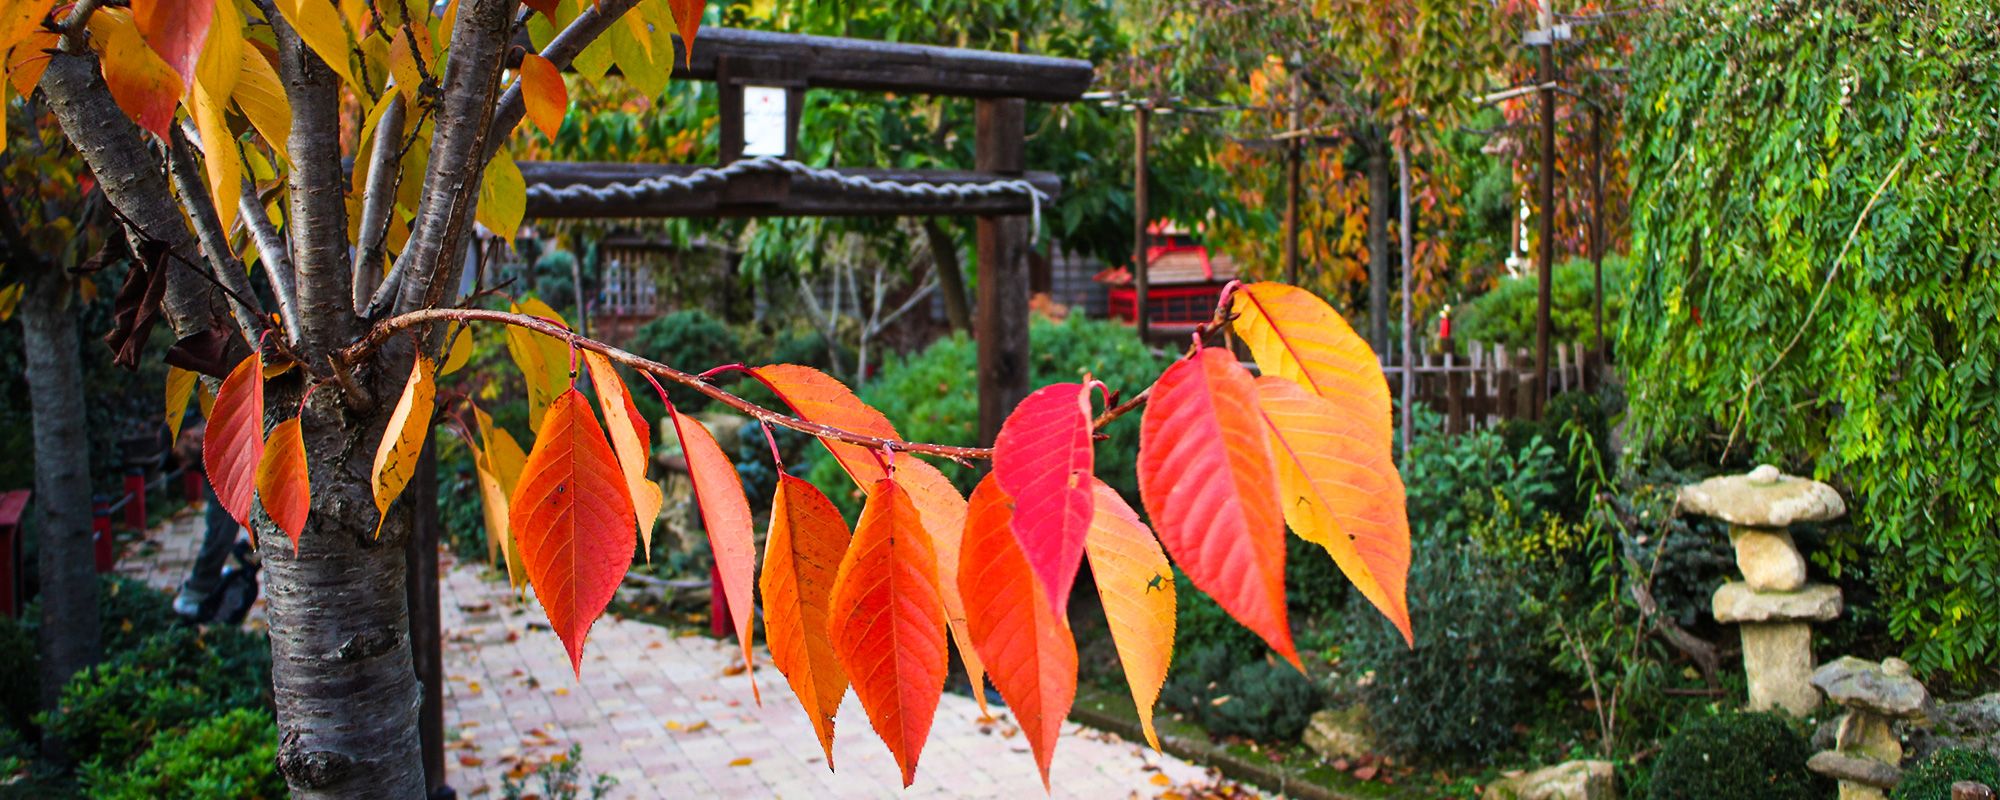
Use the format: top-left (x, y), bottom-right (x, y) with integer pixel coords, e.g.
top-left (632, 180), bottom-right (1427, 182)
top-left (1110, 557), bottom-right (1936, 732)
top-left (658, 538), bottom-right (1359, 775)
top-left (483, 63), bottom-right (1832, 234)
top-left (1680, 464), bottom-right (1848, 716)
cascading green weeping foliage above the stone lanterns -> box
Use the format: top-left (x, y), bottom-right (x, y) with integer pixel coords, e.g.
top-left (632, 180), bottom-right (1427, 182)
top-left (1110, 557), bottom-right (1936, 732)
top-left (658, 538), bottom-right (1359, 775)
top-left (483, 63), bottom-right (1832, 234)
top-left (1620, 0), bottom-right (2000, 678)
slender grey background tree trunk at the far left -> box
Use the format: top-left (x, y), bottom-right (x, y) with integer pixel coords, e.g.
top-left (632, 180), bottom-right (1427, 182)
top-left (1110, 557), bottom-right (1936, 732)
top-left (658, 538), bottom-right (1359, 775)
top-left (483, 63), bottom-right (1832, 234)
top-left (20, 268), bottom-right (98, 724)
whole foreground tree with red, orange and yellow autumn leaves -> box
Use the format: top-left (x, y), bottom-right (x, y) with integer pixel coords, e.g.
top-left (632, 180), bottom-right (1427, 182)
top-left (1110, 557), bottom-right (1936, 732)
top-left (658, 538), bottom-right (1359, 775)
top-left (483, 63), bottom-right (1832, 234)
top-left (0, 0), bottom-right (1410, 798)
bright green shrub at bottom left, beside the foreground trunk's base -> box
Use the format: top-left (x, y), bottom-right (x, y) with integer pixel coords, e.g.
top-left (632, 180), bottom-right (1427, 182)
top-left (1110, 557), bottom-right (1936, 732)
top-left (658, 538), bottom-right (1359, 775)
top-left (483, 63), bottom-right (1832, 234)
top-left (82, 708), bottom-right (286, 800)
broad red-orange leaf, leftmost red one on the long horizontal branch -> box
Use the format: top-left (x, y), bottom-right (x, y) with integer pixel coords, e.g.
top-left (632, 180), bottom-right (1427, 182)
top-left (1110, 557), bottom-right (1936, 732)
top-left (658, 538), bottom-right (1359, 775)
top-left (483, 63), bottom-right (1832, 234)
top-left (508, 388), bottom-right (638, 676)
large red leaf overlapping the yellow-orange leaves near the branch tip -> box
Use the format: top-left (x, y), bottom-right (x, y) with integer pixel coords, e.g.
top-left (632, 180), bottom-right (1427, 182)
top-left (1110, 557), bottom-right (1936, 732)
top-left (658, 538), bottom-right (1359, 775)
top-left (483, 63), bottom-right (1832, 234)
top-left (1138, 348), bottom-right (1298, 666)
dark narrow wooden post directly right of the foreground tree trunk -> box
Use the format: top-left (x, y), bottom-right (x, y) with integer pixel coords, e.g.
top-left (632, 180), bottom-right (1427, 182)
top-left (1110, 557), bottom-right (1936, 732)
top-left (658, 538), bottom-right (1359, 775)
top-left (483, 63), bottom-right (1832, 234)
top-left (402, 436), bottom-right (444, 798)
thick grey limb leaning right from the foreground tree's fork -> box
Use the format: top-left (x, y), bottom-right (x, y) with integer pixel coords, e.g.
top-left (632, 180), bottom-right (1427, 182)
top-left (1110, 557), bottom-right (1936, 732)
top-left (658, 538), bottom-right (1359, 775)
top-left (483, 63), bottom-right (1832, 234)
top-left (396, 0), bottom-right (518, 310)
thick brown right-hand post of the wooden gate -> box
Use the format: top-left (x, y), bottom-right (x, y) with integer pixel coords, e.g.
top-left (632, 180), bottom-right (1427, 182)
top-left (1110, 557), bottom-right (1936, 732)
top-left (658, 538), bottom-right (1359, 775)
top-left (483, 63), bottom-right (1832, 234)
top-left (974, 98), bottom-right (1032, 444)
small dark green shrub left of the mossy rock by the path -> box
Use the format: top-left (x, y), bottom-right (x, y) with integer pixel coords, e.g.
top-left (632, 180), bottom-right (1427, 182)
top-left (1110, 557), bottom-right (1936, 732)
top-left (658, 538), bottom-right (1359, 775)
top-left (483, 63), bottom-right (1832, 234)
top-left (1162, 636), bottom-right (1326, 742)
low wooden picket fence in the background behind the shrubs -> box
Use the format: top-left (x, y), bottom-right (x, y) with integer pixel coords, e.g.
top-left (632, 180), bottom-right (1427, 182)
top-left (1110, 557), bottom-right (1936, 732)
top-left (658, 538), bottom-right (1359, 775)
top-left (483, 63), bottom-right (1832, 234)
top-left (1382, 342), bottom-right (1602, 434)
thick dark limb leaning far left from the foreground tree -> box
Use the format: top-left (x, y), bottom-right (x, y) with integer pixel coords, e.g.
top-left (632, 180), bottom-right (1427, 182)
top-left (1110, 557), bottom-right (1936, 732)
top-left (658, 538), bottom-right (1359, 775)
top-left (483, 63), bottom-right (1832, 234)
top-left (40, 50), bottom-right (231, 346)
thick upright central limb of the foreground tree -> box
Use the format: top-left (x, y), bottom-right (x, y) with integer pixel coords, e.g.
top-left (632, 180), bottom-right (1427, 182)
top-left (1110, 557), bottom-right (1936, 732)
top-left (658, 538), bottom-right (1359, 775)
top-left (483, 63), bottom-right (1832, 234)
top-left (270, 14), bottom-right (360, 360)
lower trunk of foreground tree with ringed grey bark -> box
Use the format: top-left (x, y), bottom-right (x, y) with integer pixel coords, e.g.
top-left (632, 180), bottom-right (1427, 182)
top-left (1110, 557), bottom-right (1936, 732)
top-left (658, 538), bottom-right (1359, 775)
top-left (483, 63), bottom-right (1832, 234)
top-left (254, 376), bottom-right (424, 800)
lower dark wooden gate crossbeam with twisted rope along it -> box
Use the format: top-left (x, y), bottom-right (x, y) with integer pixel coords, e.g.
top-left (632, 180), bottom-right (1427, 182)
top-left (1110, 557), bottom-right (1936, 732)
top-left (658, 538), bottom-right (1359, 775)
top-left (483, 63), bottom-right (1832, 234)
top-left (520, 162), bottom-right (1062, 220)
